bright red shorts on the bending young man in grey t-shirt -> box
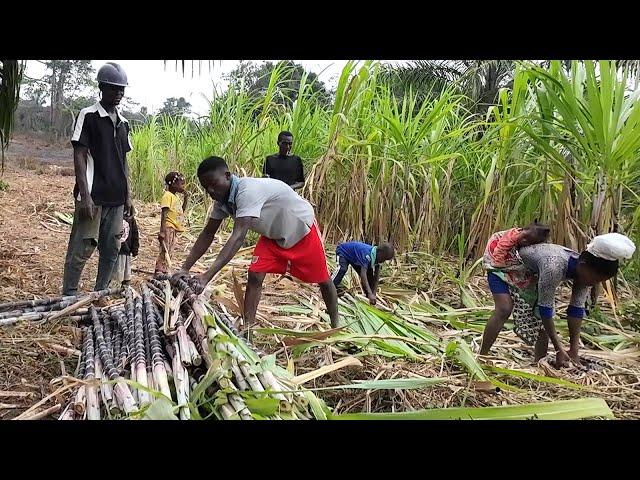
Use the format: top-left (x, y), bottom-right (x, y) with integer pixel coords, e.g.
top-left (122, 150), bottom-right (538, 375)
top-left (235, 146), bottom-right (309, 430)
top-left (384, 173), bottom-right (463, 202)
top-left (249, 223), bottom-right (330, 283)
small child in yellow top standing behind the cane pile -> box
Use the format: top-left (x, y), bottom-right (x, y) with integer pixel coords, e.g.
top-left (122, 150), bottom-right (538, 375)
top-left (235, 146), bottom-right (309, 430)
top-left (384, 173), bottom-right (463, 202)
top-left (155, 172), bottom-right (189, 274)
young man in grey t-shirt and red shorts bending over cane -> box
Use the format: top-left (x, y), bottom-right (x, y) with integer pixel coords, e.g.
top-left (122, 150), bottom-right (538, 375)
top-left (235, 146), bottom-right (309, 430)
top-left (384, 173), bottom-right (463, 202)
top-left (170, 157), bottom-right (338, 327)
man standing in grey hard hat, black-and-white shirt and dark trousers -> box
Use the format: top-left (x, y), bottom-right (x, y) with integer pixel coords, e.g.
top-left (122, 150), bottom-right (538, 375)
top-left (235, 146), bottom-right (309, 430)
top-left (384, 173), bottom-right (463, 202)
top-left (62, 62), bottom-right (133, 295)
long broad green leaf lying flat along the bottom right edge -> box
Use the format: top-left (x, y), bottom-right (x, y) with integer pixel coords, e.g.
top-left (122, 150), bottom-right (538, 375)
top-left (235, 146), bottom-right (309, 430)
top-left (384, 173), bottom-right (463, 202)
top-left (330, 398), bottom-right (615, 420)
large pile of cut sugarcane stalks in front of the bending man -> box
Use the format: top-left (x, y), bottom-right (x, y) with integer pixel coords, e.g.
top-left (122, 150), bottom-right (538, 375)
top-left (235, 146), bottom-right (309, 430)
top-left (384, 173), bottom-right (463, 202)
top-left (59, 277), bottom-right (326, 420)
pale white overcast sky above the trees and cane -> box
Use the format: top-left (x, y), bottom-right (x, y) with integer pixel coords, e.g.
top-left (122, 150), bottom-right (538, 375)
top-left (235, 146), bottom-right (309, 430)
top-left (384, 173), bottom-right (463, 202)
top-left (26, 60), bottom-right (362, 115)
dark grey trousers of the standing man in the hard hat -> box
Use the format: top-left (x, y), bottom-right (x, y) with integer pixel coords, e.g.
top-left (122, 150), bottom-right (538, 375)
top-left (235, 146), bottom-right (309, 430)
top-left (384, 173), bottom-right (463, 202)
top-left (62, 200), bottom-right (124, 295)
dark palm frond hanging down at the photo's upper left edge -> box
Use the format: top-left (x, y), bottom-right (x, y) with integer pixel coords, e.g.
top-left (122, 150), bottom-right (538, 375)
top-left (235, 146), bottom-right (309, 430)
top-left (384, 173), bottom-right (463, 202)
top-left (0, 60), bottom-right (25, 173)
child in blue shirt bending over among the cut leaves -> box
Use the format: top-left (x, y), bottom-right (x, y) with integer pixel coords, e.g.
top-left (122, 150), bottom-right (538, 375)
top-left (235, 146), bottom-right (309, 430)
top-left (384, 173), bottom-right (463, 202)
top-left (331, 242), bottom-right (395, 305)
